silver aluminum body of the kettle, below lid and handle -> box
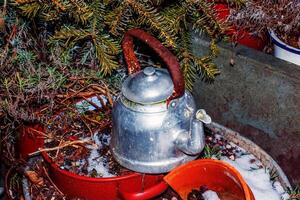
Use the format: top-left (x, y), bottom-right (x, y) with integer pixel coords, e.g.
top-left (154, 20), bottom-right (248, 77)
top-left (111, 92), bottom-right (204, 173)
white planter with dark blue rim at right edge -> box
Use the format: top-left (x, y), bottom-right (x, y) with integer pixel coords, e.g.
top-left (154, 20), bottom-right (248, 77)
top-left (269, 31), bottom-right (300, 65)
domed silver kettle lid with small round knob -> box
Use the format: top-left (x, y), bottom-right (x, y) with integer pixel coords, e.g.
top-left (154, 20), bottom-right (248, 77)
top-left (122, 67), bottom-right (174, 104)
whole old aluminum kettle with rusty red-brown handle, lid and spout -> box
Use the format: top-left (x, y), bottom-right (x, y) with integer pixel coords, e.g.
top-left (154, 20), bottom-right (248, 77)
top-left (110, 29), bottom-right (211, 173)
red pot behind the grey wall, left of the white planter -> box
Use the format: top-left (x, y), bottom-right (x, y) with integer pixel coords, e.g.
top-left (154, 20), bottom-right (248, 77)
top-left (213, 3), bottom-right (267, 50)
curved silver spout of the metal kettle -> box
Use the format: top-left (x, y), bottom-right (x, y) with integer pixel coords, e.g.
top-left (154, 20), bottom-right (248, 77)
top-left (175, 109), bottom-right (211, 155)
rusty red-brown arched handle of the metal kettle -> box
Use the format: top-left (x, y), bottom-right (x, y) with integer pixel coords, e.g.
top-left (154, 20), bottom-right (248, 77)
top-left (122, 29), bottom-right (185, 102)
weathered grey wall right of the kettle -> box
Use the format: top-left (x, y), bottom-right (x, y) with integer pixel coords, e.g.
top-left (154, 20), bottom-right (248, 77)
top-left (193, 36), bottom-right (300, 185)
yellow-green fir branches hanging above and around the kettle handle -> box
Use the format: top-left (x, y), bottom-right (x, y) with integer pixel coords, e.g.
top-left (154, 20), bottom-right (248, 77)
top-left (9, 0), bottom-right (232, 89)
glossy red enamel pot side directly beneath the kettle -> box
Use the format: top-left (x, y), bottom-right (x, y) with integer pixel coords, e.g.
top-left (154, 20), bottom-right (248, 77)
top-left (42, 152), bottom-right (167, 200)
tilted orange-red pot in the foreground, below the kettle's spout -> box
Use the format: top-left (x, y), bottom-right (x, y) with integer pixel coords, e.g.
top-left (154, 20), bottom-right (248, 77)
top-left (164, 159), bottom-right (255, 200)
